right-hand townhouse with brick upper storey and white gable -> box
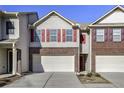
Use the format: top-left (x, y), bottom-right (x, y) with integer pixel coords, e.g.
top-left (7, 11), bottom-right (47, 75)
top-left (90, 6), bottom-right (124, 72)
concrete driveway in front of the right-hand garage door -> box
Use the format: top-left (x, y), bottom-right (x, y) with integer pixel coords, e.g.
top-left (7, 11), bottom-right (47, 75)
top-left (100, 72), bottom-right (124, 88)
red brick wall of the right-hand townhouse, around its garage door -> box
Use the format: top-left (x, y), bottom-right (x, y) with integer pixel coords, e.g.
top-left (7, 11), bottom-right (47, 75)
top-left (92, 31), bottom-right (124, 71)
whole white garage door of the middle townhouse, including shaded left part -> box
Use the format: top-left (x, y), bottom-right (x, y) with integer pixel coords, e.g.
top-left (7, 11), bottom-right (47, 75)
top-left (33, 55), bottom-right (74, 72)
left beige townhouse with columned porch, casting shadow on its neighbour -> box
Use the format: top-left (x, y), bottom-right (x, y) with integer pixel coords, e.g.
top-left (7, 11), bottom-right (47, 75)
top-left (0, 11), bottom-right (38, 74)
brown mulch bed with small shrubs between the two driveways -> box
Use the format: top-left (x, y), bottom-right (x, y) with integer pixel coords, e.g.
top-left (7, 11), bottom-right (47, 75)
top-left (77, 75), bottom-right (111, 84)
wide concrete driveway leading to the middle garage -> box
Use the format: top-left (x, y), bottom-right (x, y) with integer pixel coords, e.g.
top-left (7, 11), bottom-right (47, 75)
top-left (4, 72), bottom-right (84, 88)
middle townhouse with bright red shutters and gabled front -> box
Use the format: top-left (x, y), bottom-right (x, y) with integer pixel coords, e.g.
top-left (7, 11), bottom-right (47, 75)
top-left (29, 11), bottom-right (80, 72)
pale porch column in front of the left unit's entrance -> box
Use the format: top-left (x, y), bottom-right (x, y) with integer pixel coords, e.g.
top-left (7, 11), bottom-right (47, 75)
top-left (12, 43), bottom-right (17, 75)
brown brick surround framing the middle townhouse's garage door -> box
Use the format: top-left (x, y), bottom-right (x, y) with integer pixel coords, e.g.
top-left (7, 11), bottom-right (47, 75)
top-left (29, 48), bottom-right (79, 72)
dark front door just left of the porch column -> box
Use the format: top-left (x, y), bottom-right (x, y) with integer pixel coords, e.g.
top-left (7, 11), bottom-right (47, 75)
top-left (8, 50), bottom-right (13, 73)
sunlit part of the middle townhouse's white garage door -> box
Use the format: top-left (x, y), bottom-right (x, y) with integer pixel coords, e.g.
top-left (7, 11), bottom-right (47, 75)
top-left (42, 56), bottom-right (74, 72)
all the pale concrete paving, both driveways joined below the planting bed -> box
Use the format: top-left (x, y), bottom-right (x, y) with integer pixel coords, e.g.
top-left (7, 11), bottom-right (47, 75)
top-left (4, 72), bottom-right (121, 88)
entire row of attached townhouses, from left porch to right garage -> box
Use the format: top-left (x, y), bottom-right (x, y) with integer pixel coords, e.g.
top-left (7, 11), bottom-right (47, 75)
top-left (0, 6), bottom-right (124, 74)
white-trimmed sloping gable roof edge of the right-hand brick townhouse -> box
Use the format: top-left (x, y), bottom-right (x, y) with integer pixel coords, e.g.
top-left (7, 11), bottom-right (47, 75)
top-left (89, 5), bottom-right (124, 26)
